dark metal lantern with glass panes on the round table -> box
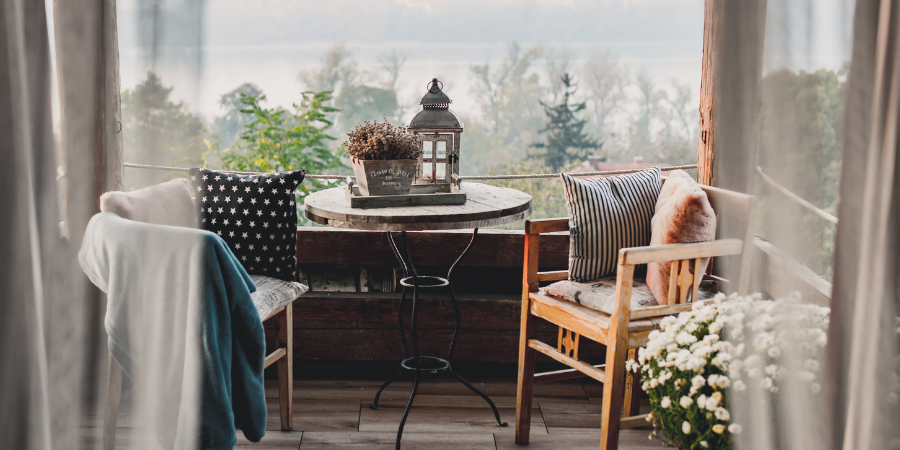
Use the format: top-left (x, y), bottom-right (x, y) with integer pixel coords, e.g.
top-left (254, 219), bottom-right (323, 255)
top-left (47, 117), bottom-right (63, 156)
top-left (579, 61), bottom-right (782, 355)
top-left (409, 78), bottom-right (463, 191)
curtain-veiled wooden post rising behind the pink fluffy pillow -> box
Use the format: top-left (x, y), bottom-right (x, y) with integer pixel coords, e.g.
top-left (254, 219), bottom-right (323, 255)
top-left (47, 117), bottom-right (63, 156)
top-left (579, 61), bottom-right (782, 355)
top-left (697, 0), bottom-right (766, 193)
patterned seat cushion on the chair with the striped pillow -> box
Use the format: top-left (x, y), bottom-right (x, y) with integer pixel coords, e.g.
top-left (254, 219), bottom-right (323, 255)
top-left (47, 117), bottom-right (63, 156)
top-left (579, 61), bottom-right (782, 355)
top-left (544, 277), bottom-right (658, 315)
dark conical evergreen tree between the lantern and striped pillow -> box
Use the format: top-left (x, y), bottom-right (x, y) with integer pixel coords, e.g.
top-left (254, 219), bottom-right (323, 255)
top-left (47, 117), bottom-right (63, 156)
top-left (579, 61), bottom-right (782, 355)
top-left (532, 73), bottom-right (602, 172)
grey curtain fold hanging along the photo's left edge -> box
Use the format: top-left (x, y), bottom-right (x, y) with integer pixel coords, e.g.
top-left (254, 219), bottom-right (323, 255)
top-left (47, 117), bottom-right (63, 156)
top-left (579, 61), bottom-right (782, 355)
top-left (0, 0), bottom-right (67, 449)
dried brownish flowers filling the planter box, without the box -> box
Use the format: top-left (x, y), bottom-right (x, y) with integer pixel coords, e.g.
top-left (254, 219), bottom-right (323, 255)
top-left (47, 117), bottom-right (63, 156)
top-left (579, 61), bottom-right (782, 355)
top-left (344, 120), bottom-right (422, 161)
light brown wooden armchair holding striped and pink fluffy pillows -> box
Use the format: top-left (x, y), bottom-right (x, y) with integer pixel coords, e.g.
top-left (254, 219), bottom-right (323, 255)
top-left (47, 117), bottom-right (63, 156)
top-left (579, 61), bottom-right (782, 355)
top-left (516, 186), bottom-right (755, 450)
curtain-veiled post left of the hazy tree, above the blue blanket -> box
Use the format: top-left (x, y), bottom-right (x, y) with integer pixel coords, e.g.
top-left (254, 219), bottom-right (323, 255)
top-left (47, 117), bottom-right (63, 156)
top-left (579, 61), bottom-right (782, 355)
top-left (54, 0), bottom-right (123, 243)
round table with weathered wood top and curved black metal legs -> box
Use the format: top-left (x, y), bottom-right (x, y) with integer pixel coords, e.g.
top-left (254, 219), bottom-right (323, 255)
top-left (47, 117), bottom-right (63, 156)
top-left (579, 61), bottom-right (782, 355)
top-left (304, 183), bottom-right (531, 450)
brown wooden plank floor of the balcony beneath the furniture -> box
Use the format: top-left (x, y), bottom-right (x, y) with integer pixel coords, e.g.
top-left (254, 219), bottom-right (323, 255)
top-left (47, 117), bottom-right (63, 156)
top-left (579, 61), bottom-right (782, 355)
top-left (91, 367), bottom-right (669, 450)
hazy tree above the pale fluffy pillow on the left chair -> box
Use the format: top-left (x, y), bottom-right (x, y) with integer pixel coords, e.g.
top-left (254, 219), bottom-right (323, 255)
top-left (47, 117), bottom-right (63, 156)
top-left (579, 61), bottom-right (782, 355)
top-left (122, 72), bottom-right (206, 189)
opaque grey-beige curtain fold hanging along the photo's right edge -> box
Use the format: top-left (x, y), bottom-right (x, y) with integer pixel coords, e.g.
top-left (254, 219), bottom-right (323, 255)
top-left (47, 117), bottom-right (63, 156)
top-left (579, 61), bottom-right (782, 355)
top-left (829, 0), bottom-right (900, 449)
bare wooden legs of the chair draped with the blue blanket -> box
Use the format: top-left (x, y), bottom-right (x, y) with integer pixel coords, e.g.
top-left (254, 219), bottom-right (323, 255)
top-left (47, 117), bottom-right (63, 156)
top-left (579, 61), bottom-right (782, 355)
top-left (103, 302), bottom-right (294, 450)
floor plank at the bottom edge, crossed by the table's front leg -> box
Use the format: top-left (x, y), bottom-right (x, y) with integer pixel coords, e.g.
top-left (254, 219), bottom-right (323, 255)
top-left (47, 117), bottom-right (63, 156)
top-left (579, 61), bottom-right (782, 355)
top-left (300, 430), bottom-right (495, 450)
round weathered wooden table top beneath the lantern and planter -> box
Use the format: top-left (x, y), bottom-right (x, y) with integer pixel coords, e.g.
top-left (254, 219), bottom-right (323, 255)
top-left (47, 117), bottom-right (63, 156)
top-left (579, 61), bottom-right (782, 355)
top-left (304, 183), bottom-right (531, 231)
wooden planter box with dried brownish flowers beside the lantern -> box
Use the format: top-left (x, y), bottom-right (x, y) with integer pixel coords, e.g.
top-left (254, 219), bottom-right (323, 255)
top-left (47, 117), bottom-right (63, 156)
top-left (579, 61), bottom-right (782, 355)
top-left (344, 121), bottom-right (422, 195)
